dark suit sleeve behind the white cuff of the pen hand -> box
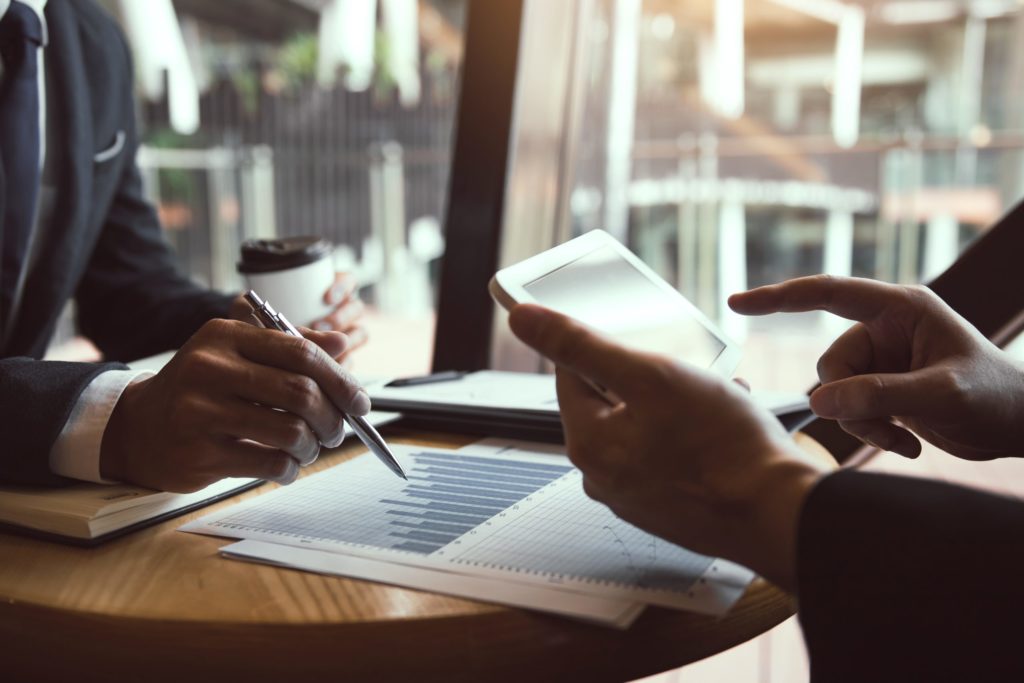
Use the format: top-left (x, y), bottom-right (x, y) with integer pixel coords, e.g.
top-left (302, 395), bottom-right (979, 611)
top-left (0, 357), bottom-right (124, 485)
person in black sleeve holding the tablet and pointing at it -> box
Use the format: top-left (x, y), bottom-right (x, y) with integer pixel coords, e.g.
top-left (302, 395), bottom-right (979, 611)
top-left (510, 278), bottom-right (1024, 681)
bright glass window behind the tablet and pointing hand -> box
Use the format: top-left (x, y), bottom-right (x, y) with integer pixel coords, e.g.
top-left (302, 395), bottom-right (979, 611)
top-left (495, 0), bottom-right (1024, 389)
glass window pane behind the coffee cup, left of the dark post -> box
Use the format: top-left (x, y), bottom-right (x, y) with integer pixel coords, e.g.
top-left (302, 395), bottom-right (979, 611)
top-left (55, 0), bottom-right (467, 375)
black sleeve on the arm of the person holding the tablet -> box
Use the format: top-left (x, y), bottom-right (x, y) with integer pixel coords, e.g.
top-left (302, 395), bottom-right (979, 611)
top-left (798, 471), bottom-right (1024, 681)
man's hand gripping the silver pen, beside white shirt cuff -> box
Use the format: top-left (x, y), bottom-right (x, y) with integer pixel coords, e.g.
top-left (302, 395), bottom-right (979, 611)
top-left (100, 319), bottom-right (370, 492)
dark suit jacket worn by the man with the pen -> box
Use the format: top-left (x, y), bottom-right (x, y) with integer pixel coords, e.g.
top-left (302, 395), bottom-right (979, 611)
top-left (0, 0), bottom-right (230, 483)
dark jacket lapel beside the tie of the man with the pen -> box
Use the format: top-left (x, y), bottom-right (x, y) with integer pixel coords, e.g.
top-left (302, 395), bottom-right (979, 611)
top-left (8, 0), bottom-right (93, 358)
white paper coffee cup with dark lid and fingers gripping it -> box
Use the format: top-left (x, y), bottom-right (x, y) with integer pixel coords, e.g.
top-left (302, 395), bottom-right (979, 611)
top-left (238, 237), bottom-right (367, 360)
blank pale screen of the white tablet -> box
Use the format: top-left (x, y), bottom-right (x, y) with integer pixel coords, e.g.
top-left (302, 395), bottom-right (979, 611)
top-left (524, 247), bottom-right (725, 368)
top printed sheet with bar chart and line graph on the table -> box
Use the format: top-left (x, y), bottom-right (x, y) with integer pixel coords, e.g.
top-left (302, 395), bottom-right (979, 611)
top-left (182, 446), bottom-right (753, 626)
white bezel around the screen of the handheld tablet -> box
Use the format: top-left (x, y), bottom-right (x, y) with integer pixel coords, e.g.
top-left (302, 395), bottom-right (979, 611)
top-left (487, 229), bottom-right (741, 378)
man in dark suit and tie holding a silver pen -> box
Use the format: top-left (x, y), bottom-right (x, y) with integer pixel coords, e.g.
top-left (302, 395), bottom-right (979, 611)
top-left (0, 0), bottom-right (370, 490)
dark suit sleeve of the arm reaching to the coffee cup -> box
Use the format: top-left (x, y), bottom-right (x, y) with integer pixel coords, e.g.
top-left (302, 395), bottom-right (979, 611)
top-left (76, 32), bottom-right (231, 360)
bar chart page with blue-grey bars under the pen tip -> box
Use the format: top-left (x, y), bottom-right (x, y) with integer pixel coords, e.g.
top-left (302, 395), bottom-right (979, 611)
top-left (199, 452), bottom-right (572, 555)
